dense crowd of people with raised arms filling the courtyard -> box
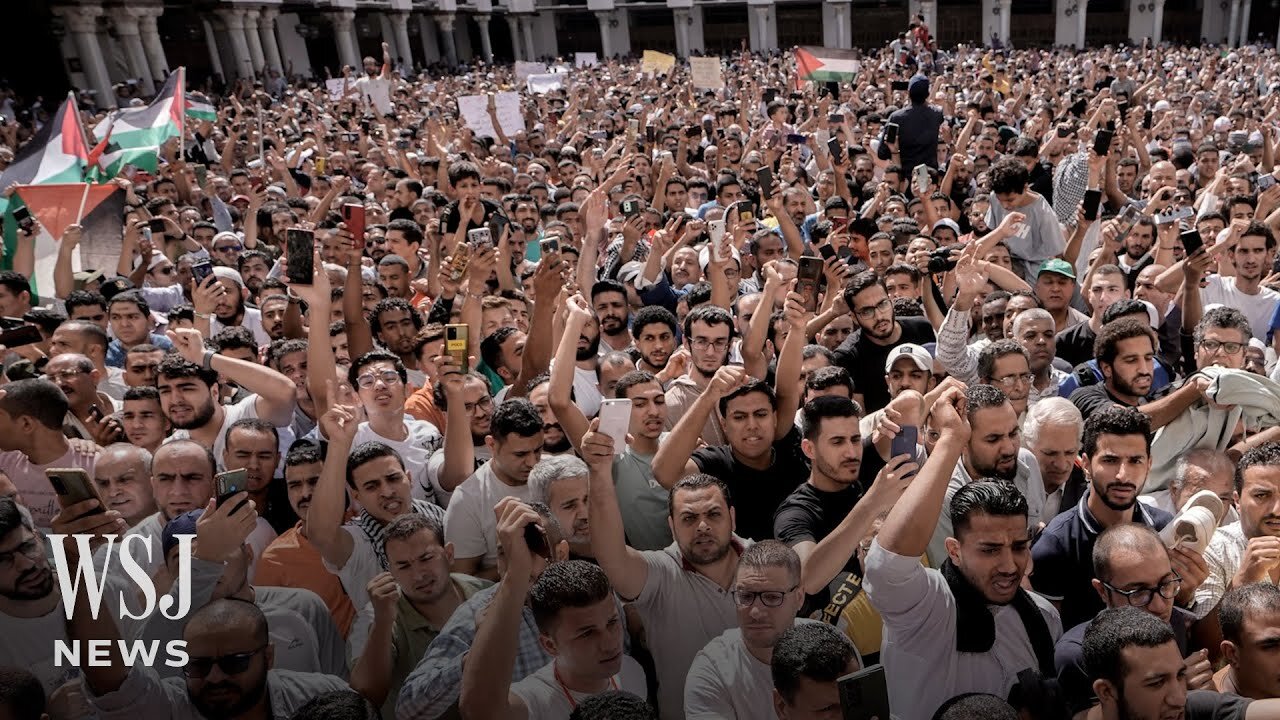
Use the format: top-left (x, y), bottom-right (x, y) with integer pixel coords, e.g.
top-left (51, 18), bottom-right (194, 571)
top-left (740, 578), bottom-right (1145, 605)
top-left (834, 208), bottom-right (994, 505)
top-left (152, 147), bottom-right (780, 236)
top-left (10, 20), bottom-right (1280, 720)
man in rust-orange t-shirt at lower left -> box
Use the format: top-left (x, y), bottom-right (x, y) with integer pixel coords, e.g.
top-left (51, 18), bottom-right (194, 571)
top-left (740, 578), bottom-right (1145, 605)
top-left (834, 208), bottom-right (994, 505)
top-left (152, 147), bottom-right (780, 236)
top-left (253, 441), bottom-right (356, 637)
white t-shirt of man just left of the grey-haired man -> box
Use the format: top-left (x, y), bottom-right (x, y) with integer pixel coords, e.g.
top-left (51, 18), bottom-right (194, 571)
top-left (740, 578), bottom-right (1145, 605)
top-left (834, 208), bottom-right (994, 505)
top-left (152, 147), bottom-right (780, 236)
top-left (442, 460), bottom-right (532, 571)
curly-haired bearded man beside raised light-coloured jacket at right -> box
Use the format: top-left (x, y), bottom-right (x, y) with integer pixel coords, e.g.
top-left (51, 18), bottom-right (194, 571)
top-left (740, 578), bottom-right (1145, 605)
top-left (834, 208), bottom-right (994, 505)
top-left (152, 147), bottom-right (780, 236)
top-left (1070, 318), bottom-right (1157, 420)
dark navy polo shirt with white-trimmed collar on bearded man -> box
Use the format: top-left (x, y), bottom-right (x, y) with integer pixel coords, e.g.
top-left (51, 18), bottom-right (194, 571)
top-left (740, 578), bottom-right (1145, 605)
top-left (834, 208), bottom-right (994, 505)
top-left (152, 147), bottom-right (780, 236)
top-left (1032, 488), bottom-right (1174, 628)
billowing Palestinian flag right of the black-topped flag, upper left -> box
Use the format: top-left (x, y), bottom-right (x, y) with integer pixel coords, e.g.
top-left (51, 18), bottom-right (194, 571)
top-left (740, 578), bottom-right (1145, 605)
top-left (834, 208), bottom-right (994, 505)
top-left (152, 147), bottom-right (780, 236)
top-left (93, 68), bottom-right (186, 179)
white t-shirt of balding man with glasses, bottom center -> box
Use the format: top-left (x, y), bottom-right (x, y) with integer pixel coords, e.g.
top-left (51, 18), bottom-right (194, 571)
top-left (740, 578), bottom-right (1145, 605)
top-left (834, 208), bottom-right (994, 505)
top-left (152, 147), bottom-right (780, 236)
top-left (685, 628), bottom-right (777, 720)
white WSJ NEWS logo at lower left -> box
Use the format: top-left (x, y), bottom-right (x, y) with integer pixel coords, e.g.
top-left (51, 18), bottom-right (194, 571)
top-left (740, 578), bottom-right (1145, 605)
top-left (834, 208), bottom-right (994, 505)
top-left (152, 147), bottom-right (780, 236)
top-left (49, 534), bottom-right (196, 667)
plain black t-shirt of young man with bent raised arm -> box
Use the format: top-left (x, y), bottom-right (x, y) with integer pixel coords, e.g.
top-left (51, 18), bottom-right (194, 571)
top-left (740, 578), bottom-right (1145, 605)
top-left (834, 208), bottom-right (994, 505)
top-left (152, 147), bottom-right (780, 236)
top-left (692, 418), bottom-right (809, 541)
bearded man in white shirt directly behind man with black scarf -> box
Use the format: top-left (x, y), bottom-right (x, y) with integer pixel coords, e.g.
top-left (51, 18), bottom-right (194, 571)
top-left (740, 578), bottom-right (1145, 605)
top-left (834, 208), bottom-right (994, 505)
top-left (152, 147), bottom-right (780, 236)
top-left (928, 386), bottom-right (1048, 568)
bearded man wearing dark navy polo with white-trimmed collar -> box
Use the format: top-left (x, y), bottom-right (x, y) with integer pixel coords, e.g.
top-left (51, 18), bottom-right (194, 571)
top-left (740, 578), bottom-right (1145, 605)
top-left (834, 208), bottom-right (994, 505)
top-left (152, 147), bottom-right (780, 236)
top-left (1030, 404), bottom-right (1172, 626)
